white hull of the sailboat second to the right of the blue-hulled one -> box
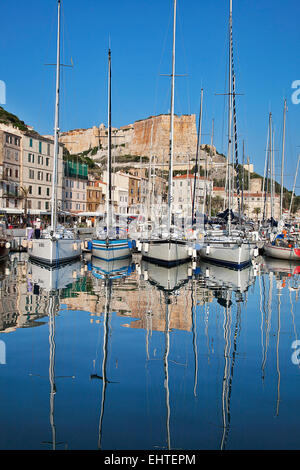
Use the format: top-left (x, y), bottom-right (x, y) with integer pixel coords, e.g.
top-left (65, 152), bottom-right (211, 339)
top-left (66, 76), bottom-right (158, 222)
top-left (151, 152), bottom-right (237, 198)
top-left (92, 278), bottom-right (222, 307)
top-left (200, 242), bottom-right (254, 269)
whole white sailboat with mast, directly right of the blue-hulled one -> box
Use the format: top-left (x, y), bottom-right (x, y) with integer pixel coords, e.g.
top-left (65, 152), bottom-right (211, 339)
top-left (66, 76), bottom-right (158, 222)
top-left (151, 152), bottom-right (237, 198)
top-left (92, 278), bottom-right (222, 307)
top-left (141, 0), bottom-right (193, 266)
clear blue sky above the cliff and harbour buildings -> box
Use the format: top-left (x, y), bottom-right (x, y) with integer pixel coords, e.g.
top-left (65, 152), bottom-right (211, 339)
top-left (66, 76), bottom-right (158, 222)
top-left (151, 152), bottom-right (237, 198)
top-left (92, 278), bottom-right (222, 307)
top-left (0, 0), bottom-right (300, 194)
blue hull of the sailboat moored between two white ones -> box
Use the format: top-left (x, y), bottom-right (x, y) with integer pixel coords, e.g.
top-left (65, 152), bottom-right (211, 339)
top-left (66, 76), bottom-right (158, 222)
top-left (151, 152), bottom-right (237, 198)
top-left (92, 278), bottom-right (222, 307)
top-left (92, 238), bottom-right (132, 261)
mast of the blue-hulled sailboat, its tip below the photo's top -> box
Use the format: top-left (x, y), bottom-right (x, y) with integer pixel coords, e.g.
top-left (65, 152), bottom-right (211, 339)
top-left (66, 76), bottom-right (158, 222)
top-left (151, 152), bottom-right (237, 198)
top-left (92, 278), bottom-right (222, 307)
top-left (106, 48), bottom-right (112, 238)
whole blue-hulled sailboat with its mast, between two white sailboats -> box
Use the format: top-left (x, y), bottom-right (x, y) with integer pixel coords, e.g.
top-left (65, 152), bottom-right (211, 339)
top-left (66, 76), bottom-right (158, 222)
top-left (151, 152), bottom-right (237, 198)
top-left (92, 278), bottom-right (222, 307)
top-left (92, 49), bottom-right (132, 261)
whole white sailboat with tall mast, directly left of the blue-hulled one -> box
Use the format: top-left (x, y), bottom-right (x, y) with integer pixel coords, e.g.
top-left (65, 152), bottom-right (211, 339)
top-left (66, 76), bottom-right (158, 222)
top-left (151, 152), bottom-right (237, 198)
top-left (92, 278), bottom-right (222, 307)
top-left (28, 0), bottom-right (81, 265)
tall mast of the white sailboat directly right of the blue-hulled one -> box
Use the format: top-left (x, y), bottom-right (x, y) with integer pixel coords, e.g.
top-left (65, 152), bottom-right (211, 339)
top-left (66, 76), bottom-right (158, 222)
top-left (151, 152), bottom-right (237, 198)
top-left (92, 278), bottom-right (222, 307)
top-left (168, 0), bottom-right (177, 235)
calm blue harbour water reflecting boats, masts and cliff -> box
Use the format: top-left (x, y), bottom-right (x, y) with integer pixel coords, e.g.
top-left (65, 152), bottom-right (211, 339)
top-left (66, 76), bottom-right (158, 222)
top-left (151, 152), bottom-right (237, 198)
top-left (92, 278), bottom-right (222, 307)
top-left (0, 254), bottom-right (300, 451)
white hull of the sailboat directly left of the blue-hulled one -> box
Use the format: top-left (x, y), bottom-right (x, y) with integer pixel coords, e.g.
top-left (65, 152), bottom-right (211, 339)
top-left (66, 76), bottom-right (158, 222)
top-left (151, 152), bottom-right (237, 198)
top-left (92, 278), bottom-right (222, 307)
top-left (27, 238), bottom-right (81, 266)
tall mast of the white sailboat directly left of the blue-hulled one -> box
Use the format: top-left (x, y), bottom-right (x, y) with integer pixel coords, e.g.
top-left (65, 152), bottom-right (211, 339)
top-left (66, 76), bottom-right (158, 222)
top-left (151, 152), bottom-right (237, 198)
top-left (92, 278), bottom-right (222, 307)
top-left (51, 0), bottom-right (61, 232)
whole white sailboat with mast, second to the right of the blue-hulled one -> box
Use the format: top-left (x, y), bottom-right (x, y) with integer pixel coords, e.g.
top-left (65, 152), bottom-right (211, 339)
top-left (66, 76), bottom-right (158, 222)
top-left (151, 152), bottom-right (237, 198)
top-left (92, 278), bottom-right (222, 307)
top-left (200, 0), bottom-right (258, 269)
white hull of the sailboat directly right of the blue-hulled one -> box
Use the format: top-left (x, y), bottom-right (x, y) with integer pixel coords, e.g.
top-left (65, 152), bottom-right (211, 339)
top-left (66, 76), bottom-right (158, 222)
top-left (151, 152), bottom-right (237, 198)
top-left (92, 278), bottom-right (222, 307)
top-left (141, 240), bottom-right (191, 266)
